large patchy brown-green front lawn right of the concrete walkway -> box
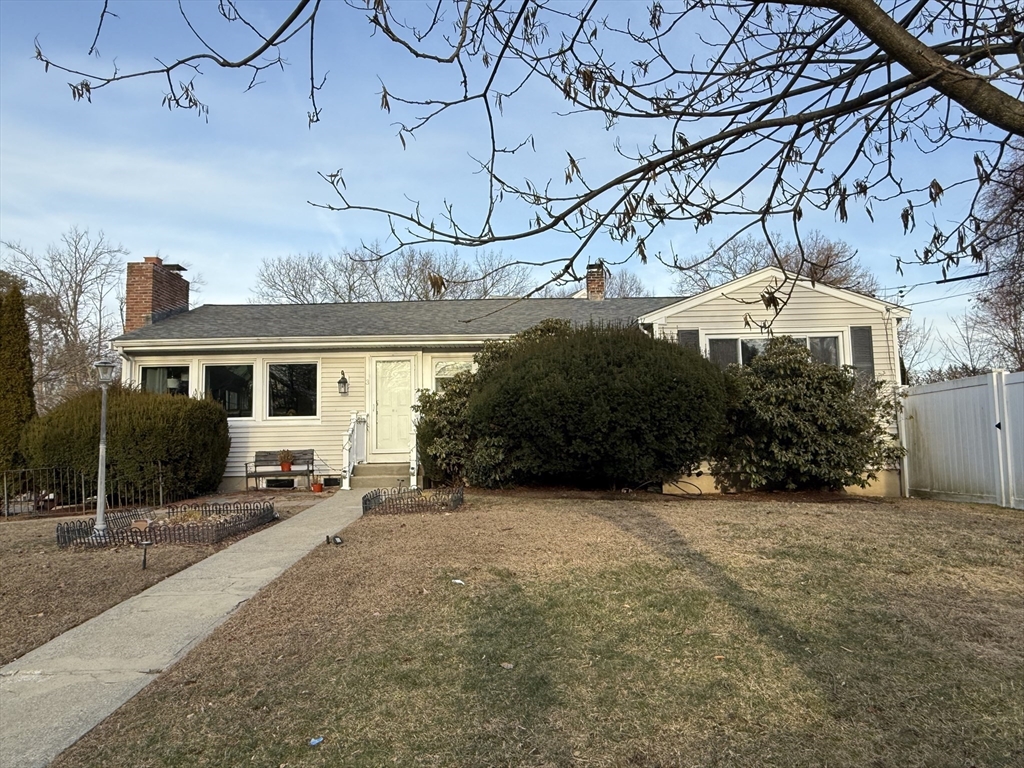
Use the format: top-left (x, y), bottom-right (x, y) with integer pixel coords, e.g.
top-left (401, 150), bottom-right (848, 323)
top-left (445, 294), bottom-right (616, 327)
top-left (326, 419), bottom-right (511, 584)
top-left (48, 495), bottom-right (1024, 768)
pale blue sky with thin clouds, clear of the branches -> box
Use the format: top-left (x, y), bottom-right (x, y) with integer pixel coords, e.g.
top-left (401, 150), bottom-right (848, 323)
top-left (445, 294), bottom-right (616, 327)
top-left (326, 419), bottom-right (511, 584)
top-left (0, 0), bottom-right (991, 352)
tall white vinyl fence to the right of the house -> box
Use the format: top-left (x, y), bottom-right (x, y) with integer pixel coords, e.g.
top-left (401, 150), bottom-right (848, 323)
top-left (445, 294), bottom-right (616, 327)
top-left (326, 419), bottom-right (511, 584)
top-left (903, 372), bottom-right (1024, 509)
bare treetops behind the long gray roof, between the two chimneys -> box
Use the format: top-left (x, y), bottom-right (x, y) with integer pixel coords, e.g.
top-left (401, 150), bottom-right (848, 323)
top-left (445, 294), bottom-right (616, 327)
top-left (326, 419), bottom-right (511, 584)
top-left (253, 247), bottom-right (530, 304)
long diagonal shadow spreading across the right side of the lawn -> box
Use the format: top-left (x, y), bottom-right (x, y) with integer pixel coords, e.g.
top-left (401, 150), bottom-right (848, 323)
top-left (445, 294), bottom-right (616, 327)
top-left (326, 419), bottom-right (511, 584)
top-left (594, 506), bottom-right (1024, 765)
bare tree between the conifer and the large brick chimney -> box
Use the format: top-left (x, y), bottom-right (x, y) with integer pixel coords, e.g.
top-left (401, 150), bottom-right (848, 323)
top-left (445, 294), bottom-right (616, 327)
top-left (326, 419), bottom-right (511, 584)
top-left (2, 226), bottom-right (128, 410)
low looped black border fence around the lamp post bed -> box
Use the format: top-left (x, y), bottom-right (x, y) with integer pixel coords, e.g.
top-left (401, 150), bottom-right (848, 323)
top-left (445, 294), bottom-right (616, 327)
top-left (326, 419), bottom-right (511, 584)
top-left (57, 502), bottom-right (278, 548)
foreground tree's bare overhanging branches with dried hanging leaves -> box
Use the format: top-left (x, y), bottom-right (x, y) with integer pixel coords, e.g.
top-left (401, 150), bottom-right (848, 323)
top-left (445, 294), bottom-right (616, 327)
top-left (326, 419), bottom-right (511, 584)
top-left (36, 0), bottom-right (1024, 309)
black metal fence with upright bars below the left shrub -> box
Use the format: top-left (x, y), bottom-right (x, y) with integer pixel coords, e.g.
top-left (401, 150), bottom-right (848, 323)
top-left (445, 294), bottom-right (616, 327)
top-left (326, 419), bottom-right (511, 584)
top-left (0, 462), bottom-right (178, 517)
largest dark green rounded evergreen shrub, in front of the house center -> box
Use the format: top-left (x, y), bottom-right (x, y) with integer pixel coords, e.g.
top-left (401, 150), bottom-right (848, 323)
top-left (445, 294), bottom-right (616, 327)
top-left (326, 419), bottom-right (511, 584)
top-left (465, 327), bottom-right (725, 487)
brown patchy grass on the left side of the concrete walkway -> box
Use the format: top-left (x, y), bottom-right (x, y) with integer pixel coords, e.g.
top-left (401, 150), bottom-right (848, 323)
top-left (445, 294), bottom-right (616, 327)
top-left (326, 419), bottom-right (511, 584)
top-left (0, 493), bottom-right (317, 665)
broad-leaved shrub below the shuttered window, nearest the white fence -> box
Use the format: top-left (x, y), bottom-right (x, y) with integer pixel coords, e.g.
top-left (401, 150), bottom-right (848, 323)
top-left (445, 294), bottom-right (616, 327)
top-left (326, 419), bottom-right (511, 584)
top-left (712, 337), bottom-right (902, 490)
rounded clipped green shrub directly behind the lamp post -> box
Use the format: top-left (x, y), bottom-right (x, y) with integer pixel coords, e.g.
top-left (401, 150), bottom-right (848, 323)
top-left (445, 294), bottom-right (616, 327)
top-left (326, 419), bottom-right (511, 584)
top-left (23, 385), bottom-right (230, 499)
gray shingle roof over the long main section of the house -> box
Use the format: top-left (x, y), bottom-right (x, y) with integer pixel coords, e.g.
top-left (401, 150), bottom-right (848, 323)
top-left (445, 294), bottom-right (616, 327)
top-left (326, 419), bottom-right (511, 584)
top-left (117, 296), bottom-right (681, 342)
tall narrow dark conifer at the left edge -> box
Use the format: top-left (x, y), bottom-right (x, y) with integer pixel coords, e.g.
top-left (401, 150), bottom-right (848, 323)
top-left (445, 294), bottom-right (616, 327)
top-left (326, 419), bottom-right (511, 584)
top-left (0, 285), bottom-right (36, 470)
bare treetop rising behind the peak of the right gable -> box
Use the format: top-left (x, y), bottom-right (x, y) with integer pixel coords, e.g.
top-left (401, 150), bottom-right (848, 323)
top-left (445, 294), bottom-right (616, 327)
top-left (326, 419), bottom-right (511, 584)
top-left (673, 229), bottom-right (881, 296)
